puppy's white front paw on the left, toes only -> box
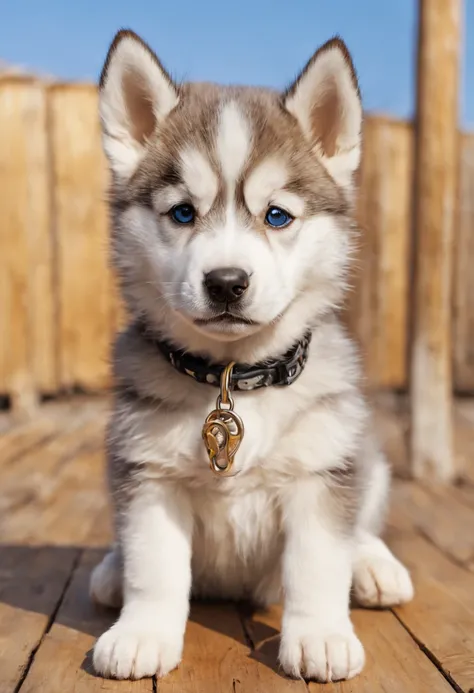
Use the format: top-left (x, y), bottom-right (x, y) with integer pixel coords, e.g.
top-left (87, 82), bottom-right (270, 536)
top-left (93, 618), bottom-right (183, 679)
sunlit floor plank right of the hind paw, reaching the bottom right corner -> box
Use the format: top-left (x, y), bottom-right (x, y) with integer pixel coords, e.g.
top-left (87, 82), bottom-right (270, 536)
top-left (388, 502), bottom-right (474, 693)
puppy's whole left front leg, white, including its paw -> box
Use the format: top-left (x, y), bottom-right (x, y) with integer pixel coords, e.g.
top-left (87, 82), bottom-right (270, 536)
top-left (93, 485), bottom-right (192, 679)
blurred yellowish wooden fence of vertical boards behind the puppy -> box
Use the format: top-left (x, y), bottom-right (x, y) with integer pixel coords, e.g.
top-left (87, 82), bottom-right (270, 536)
top-left (0, 77), bottom-right (474, 406)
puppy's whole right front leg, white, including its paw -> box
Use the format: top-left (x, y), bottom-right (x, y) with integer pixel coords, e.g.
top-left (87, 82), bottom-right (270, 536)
top-left (280, 476), bottom-right (364, 682)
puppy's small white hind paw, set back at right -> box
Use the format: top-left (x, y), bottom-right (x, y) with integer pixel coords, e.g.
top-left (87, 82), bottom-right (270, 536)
top-left (352, 554), bottom-right (413, 607)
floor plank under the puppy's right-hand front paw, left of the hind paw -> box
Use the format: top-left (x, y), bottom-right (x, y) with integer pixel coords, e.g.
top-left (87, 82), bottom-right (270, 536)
top-left (247, 607), bottom-right (451, 693)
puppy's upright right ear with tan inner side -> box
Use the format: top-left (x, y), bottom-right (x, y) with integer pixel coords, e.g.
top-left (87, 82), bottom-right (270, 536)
top-left (285, 38), bottom-right (362, 189)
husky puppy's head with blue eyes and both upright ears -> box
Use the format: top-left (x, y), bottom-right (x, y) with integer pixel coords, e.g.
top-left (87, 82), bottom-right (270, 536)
top-left (100, 32), bottom-right (361, 340)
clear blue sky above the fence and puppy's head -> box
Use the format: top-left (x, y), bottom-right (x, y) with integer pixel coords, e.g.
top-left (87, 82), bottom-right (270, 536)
top-left (0, 0), bottom-right (474, 129)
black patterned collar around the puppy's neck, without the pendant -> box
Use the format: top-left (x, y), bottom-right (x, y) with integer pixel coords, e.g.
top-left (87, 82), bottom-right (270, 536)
top-left (140, 325), bottom-right (312, 390)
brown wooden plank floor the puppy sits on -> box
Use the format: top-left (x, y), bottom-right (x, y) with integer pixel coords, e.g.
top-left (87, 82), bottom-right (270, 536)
top-left (0, 399), bottom-right (474, 693)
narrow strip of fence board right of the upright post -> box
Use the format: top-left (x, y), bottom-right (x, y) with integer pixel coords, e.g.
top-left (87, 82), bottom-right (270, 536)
top-left (453, 135), bottom-right (474, 392)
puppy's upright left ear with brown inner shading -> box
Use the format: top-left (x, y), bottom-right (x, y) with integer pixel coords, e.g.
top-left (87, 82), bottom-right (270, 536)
top-left (99, 30), bottom-right (179, 180)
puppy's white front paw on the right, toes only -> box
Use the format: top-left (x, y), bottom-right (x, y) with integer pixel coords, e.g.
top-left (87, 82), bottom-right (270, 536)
top-left (280, 615), bottom-right (365, 683)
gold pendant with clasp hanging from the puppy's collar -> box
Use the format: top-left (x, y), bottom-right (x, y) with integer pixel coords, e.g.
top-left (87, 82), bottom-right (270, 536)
top-left (202, 363), bottom-right (244, 476)
